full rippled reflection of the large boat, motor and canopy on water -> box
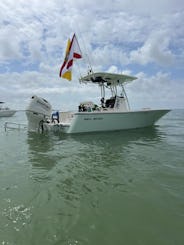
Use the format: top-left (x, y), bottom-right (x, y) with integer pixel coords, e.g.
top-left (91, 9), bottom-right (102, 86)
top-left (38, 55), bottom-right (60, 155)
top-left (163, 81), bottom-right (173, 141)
top-left (27, 126), bottom-right (164, 196)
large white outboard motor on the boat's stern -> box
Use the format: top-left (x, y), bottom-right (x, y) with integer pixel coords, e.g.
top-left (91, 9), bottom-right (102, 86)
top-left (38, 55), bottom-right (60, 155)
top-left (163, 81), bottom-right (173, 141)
top-left (26, 95), bottom-right (52, 132)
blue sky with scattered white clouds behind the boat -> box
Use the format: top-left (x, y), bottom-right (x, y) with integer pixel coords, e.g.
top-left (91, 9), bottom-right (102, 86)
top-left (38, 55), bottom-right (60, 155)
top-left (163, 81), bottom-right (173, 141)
top-left (0, 0), bottom-right (184, 110)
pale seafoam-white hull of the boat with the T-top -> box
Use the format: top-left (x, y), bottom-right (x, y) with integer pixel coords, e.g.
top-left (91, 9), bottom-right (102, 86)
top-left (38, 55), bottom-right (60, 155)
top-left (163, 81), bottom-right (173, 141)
top-left (43, 110), bottom-right (169, 134)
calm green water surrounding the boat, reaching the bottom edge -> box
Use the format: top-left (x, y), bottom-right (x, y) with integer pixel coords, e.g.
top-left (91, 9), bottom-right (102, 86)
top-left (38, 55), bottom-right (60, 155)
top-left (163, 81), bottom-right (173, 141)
top-left (0, 110), bottom-right (184, 245)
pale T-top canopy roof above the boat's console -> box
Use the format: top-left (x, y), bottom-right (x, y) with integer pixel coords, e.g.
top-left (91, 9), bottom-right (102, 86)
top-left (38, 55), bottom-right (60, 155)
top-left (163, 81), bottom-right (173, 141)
top-left (80, 72), bottom-right (137, 85)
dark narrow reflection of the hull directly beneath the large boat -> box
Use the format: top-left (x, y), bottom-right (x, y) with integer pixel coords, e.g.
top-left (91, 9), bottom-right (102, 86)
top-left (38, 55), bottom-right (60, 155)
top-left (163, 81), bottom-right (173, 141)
top-left (52, 126), bottom-right (164, 161)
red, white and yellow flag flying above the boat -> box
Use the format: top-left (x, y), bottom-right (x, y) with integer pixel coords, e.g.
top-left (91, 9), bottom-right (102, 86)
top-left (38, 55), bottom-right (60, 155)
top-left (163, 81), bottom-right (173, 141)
top-left (59, 34), bottom-right (82, 81)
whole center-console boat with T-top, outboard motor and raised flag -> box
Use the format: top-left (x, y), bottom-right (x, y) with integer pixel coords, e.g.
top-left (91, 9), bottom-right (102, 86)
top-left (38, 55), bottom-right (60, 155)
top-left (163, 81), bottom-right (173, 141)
top-left (26, 34), bottom-right (169, 134)
